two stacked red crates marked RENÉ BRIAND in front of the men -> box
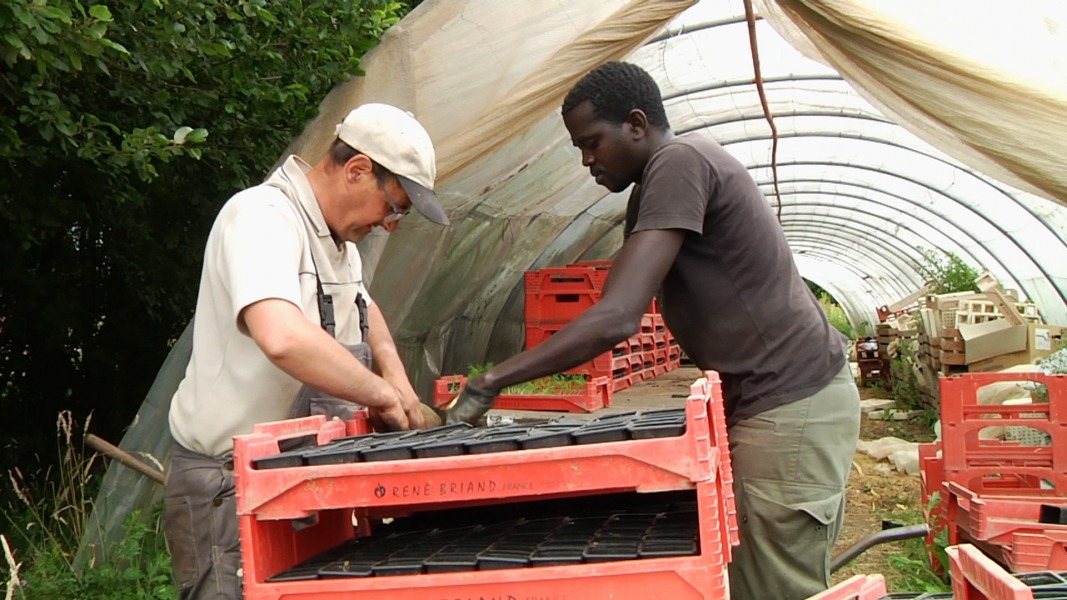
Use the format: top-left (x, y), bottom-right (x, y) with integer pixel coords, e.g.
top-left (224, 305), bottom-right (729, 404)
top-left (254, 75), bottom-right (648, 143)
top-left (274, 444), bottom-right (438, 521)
top-left (234, 374), bottom-right (736, 600)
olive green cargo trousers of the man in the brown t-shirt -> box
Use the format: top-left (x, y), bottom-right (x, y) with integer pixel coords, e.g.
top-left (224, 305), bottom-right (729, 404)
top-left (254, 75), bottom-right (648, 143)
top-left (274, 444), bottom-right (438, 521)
top-left (728, 363), bottom-right (860, 600)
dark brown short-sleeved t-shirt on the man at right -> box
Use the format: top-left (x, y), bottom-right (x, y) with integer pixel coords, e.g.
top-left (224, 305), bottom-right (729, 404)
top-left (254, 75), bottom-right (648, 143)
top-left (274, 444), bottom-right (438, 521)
top-left (625, 135), bottom-right (846, 424)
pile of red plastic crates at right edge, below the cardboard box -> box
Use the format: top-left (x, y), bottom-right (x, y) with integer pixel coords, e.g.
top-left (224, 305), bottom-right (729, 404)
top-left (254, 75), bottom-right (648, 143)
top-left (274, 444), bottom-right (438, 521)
top-left (920, 373), bottom-right (1067, 572)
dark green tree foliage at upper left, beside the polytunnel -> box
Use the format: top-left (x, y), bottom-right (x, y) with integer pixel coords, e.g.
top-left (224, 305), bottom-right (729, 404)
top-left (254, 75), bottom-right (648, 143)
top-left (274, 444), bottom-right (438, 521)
top-left (0, 0), bottom-right (408, 474)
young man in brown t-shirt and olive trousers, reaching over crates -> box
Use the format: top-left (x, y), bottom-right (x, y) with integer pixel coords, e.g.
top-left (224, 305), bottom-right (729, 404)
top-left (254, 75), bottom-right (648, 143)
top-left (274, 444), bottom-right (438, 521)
top-left (447, 62), bottom-right (860, 600)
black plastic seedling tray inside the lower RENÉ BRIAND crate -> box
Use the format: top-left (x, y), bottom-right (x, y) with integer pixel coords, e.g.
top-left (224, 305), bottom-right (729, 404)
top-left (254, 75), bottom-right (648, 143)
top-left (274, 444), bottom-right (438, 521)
top-left (268, 494), bottom-right (699, 582)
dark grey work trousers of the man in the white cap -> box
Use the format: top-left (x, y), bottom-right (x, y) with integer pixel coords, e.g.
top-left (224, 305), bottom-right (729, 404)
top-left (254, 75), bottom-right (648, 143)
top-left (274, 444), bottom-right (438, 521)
top-left (163, 443), bottom-right (242, 600)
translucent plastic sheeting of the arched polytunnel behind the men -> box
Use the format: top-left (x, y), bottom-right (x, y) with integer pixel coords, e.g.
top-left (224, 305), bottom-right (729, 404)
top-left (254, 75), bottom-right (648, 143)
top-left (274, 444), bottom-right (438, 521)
top-left (83, 0), bottom-right (1067, 555)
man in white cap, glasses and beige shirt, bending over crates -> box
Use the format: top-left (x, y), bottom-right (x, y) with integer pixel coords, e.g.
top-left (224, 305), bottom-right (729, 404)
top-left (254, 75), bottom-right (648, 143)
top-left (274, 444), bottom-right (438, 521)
top-left (164, 104), bottom-right (448, 599)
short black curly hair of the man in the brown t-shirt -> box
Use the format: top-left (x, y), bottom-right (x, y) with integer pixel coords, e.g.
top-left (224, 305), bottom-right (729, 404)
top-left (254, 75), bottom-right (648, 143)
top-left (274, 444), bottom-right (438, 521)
top-left (563, 61), bottom-right (670, 129)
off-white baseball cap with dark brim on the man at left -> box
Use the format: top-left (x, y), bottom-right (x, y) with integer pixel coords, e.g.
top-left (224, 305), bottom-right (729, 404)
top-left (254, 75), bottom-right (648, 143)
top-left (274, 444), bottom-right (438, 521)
top-left (335, 104), bottom-right (448, 225)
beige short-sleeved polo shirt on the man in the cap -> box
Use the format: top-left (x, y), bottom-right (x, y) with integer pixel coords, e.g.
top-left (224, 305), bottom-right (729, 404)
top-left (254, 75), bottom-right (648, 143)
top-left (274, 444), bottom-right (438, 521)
top-left (170, 156), bottom-right (370, 456)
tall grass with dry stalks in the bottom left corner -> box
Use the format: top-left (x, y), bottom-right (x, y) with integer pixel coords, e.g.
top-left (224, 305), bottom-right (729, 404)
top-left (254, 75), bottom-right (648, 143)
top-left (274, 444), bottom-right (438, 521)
top-left (0, 411), bottom-right (175, 600)
